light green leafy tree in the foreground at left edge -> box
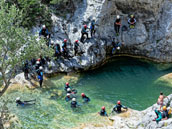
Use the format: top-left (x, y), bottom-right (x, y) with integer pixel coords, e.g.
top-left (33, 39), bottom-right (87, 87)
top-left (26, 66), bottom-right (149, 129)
top-left (0, 2), bottom-right (52, 97)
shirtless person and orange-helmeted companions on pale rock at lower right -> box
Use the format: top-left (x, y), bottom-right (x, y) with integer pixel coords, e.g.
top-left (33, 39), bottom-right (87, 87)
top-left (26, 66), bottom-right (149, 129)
top-left (153, 92), bottom-right (171, 123)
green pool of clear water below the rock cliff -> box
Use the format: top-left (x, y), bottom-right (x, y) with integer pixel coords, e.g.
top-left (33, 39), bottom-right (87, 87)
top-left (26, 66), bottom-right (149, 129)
top-left (1, 58), bottom-right (172, 129)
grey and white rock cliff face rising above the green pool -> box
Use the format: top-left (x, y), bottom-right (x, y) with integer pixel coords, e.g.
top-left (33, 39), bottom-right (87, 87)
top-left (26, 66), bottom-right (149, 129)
top-left (33, 0), bottom-right (172, 73)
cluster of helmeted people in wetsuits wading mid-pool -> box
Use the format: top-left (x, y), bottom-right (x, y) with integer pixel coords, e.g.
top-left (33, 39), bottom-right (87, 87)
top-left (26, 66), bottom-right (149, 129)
top-left (64, 82), bottom-right (90, 108)
